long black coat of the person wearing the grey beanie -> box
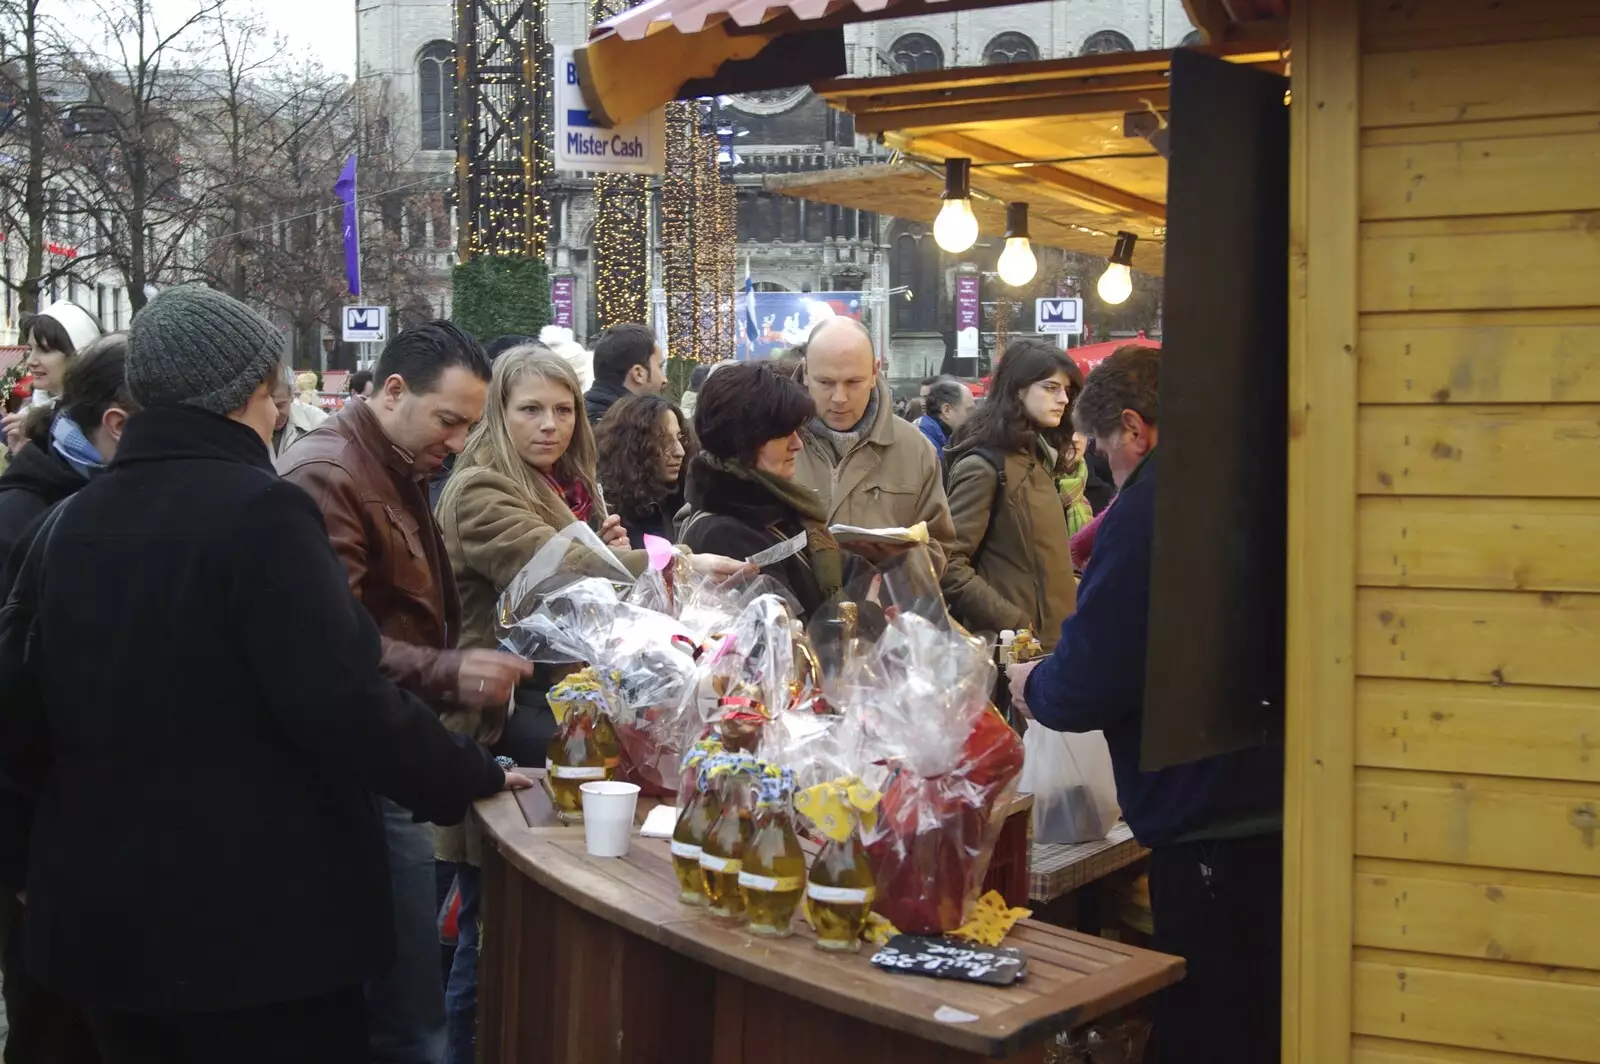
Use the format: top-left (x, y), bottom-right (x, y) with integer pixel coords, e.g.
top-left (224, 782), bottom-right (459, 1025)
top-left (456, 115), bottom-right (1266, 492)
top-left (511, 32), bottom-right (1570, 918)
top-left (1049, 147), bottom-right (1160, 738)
top-left (12, 408), bottom-right (504, 1016)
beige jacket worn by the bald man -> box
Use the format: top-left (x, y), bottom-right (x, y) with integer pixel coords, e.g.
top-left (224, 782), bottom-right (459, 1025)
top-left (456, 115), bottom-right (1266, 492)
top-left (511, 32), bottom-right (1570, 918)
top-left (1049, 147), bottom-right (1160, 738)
top-left (795, 378), bottom-right (955, 570)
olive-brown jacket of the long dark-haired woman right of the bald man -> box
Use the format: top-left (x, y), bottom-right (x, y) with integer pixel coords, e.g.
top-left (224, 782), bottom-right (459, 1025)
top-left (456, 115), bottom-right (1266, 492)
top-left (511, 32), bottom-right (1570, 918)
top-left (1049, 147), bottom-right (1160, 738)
top-left (942, 448), bottom-right (1078, 650)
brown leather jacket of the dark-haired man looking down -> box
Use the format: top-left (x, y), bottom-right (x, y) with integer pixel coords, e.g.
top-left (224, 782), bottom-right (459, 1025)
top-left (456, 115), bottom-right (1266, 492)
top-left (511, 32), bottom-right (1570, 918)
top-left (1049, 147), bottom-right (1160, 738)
top-left (278, 403), bottom-right (461, 710)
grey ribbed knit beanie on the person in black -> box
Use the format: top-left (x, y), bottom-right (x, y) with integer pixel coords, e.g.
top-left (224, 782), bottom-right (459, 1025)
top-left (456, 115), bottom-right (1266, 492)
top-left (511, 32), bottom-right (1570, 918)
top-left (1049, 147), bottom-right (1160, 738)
top-left (128, 285), bottom-right (283, 414)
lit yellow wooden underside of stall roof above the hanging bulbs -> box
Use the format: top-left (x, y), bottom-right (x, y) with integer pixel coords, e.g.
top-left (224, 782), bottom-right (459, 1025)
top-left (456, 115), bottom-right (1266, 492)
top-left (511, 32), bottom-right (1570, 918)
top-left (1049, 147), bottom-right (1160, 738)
top-left (766, 45), bottom-right (1283, 265)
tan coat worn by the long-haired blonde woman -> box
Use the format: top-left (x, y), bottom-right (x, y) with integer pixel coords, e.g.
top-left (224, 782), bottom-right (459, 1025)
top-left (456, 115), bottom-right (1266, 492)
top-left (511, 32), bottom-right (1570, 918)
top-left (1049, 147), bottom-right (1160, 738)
top-left (434, 466), bottom-right (646, 864)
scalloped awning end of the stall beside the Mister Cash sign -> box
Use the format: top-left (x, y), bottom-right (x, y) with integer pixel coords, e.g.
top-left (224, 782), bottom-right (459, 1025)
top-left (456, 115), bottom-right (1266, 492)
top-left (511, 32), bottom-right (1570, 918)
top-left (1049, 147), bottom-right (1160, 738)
top-left (578, 0), bottom-right (1043, 123)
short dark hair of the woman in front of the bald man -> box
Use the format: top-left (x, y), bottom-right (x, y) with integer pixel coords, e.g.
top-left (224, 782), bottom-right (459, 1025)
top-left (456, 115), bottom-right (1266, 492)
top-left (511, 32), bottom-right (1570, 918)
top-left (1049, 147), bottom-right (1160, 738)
top-left (694, 362), bottom-right (816, 466)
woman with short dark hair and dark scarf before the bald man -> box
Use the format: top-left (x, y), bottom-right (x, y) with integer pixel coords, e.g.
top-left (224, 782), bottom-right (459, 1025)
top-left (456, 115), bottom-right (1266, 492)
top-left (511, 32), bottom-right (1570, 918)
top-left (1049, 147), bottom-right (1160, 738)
top-left (678, 363), bottom-right (853, 621)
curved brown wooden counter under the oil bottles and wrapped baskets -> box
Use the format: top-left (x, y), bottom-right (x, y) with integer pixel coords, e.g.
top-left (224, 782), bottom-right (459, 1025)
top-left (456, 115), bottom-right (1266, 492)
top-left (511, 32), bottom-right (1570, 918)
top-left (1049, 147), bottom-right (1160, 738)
top-left (474, 784), bottom-right (1182, 1064)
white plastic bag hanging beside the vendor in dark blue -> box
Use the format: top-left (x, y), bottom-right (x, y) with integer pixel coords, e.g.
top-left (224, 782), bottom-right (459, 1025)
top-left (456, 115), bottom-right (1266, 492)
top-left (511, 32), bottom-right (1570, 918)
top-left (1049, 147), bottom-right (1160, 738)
top-left (1019, 723), bottom-right (1122, 843)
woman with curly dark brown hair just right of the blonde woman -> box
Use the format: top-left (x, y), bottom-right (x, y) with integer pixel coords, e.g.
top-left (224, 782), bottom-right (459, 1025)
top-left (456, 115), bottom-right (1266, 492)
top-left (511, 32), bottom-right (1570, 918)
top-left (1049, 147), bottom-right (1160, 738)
top-left (595, 395), bottom-right (698, 550)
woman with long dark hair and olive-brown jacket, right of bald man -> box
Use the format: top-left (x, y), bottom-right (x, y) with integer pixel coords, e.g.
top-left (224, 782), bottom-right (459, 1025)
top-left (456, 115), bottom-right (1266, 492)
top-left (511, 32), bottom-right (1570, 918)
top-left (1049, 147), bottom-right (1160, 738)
top-left (944, 339), bottom-right (1088, 650)
